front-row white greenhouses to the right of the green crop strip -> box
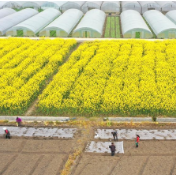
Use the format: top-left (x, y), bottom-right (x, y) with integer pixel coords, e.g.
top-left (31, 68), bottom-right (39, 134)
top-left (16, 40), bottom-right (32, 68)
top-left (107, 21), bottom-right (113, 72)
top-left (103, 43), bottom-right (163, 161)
top-left (121, 10), bottom-right (176, 39)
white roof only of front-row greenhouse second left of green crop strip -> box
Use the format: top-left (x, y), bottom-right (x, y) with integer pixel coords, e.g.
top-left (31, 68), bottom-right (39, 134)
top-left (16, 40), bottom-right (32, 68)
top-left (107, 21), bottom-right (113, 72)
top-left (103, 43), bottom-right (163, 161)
top-left (41, 9), bottom-right (84, 35)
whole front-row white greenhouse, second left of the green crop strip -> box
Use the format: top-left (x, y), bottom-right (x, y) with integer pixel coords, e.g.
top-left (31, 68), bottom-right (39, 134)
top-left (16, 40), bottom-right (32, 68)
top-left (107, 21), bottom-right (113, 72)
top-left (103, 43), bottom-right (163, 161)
top-left (40, 9), bottom-right (84, 37)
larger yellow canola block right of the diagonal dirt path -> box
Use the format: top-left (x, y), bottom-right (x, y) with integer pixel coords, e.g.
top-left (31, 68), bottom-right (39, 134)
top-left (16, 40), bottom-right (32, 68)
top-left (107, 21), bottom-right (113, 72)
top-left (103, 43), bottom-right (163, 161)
top-left (38, 40), bottom-right (176, 116)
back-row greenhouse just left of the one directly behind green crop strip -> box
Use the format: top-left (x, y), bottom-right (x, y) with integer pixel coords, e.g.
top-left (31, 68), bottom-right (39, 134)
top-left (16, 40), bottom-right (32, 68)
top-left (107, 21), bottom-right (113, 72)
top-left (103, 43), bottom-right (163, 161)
top-left (82, 1), bottom-right (103, 13)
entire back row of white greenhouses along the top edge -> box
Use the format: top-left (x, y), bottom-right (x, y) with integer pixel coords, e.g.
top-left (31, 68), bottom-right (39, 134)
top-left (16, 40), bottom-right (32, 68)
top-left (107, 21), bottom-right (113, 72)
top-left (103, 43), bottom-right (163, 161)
top-left (0, 1), bottom-right (176, 14)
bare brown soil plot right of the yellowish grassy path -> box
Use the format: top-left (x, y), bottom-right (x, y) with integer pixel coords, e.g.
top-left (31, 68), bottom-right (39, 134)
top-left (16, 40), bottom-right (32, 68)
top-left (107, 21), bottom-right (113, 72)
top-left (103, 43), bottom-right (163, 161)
top-left (72, 141), bottom-right (176, 175)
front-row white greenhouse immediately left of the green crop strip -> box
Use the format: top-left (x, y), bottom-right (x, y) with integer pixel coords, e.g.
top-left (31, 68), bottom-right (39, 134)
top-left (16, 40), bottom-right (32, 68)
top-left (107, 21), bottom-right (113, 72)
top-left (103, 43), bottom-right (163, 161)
top-left (73, 9), bottom-right (106, 38)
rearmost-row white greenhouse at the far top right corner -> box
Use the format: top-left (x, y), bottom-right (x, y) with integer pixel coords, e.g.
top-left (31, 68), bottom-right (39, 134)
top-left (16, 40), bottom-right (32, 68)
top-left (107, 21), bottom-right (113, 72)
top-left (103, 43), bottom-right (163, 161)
top-left (156, 1), bottom-right (176, 13)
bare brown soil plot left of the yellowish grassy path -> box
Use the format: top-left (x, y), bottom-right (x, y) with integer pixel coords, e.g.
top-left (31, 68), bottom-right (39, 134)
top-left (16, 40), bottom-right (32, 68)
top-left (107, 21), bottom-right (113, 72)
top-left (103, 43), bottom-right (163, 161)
top-left (0, 139), bottom-right (74, 175)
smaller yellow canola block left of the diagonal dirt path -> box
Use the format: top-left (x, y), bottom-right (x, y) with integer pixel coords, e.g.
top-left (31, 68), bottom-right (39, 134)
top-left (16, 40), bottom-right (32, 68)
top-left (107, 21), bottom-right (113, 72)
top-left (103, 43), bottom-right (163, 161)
top-left (0, 38), bottom-right (76, 114)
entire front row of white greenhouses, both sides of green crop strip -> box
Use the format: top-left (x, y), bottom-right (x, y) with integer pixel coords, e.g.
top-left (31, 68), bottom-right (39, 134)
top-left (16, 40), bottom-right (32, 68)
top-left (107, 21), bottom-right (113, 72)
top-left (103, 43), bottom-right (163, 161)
top-left (0, 8), bottom-right (176, 38)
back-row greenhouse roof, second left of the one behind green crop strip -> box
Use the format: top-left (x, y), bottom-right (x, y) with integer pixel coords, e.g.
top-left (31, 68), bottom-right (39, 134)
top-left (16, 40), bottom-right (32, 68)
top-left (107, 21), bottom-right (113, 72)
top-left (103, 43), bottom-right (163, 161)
top-left (61, 1), bottom-right (86, 12)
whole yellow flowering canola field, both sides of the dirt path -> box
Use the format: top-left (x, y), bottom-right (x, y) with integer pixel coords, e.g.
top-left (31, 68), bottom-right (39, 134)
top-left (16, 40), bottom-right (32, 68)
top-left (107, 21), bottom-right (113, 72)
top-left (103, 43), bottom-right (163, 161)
top-left (0, 39), bottom-right (176, 116)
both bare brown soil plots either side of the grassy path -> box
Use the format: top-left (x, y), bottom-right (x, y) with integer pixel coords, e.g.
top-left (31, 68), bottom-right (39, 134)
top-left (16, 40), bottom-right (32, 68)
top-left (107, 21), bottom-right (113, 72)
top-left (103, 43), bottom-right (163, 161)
top-left (0, 139), bottom-right (176, 175)
